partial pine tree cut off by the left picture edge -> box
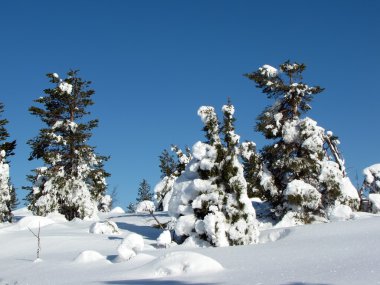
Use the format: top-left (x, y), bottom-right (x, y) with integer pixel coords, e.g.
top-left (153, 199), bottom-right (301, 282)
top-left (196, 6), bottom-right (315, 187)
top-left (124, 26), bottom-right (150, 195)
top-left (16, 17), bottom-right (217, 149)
top-left (0, 103), bottom-right (18, 223)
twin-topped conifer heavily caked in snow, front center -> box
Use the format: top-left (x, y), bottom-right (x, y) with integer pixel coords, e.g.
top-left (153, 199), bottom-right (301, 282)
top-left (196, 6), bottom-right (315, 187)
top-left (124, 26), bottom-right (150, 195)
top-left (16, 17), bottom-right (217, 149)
top-left (169, 104), bottom-right (257, 246)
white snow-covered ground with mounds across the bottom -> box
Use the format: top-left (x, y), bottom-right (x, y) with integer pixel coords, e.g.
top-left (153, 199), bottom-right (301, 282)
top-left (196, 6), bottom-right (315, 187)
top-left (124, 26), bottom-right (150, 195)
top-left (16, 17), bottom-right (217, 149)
top-left (0, 206), bottom-right (380, 285)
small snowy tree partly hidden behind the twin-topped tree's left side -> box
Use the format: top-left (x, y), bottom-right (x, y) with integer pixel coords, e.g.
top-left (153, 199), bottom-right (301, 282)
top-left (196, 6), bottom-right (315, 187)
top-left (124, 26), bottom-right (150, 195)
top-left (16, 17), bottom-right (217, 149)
top-left (154, 145), bottom-right (191, 211)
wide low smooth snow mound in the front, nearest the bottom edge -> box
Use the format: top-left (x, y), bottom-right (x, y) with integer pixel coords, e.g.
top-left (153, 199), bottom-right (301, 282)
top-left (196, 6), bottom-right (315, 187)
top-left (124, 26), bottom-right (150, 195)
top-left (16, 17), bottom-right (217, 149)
top-left (140, 251), bottom-right (223, 277)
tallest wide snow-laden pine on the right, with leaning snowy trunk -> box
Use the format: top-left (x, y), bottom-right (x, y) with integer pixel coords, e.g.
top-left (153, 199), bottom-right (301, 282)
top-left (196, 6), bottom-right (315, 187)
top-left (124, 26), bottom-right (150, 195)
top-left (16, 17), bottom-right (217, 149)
top-left (246, 61), bottom-right (359, 222)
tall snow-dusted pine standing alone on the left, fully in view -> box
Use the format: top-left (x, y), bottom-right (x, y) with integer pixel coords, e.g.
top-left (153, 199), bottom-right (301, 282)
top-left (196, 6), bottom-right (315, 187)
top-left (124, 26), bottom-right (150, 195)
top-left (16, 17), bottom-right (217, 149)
top-left (25, 71), bottom-right (110, 220)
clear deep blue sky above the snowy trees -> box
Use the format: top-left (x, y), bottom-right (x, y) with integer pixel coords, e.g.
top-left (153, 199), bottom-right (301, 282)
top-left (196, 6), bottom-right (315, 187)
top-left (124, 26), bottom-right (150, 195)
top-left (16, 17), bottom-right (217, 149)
top-left (0, 0), bottom-right (380, 207)
